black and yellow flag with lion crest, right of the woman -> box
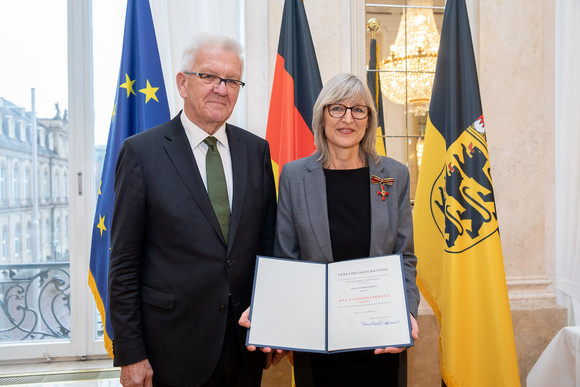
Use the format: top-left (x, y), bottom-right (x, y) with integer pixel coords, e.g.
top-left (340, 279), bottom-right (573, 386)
top-left (413, 0), bottom-right (520, 387)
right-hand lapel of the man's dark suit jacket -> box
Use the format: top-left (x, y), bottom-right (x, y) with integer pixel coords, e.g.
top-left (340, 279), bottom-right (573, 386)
top-left (226, 124), bottom-right (248, 249)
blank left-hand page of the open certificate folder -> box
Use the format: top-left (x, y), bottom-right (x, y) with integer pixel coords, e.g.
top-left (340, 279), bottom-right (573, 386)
top-left (247, 257), bottom-right (326, 352)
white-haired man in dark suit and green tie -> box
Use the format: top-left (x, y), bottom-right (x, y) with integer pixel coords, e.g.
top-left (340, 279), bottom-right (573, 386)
top-left (109, 36), bottom-right (276, 386)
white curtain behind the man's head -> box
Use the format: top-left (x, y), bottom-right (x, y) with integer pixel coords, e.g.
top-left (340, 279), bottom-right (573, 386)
top-left (150, 0), bottom-right (246, 126)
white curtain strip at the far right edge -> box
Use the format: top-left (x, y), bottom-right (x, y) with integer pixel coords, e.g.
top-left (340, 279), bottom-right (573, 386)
top-left (555, 0), bottom-right (580, 325)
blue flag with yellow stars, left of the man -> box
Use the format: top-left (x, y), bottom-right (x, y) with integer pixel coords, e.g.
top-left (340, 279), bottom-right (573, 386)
top-left (89, 0), bottom-right (170, 357)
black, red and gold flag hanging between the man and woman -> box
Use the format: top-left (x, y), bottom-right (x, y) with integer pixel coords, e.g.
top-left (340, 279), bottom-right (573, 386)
top-left (266, 0), bottom-right (322, 187)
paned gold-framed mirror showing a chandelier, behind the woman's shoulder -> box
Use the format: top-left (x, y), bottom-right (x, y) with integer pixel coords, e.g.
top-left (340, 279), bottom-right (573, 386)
top-left (366, 0), bottom-right (445, 200)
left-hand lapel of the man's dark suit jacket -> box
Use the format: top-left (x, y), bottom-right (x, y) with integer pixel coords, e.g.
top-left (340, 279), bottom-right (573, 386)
top-left (163, 113), bottom-right (225, 243)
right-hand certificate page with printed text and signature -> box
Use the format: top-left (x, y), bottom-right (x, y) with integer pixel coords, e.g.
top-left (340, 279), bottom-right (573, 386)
top-left (328, 255), bottom-right (412, 351)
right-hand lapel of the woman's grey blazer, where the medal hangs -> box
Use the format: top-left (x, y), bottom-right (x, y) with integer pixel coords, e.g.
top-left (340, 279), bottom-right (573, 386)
top-left (368, 158), bottom-right (389, 257)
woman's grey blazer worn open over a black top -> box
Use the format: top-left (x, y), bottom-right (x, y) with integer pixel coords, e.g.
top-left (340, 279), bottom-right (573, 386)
top-left (274, 153), bottom-right (419, 317)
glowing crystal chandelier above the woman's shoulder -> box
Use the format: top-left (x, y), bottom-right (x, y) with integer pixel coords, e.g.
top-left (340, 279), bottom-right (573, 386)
top-left (379, 4), bottom-right (439, 114)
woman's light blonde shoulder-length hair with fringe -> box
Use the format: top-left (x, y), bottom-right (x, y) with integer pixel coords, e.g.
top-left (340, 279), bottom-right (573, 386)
top-left (312, 74), bottom-right (380, 168)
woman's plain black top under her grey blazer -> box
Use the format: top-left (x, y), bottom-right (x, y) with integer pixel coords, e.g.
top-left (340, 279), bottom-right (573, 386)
top-left (324, 167), bottom-right (371, 261)
